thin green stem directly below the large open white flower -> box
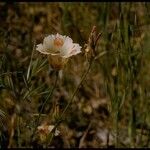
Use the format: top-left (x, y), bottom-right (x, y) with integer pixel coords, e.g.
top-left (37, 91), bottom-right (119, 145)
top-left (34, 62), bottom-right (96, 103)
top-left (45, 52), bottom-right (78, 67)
top-left (31, 72), bottom-right (58, 141)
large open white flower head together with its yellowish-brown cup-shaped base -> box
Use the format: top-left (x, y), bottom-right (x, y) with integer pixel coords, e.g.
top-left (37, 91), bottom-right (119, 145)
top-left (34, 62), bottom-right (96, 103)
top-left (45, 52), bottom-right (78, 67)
top-left (36, 33), bottom-right (81, 70)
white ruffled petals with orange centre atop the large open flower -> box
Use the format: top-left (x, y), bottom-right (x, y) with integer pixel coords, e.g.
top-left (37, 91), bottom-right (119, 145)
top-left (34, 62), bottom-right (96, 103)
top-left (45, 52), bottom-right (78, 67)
top-left (36, 33), bottom-right (81, 58)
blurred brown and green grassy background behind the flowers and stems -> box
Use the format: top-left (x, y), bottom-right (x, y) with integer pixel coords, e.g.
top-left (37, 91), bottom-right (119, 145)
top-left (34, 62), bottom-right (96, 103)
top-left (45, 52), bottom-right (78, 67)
top-left (0, 2), bottom-right (150, 148)
